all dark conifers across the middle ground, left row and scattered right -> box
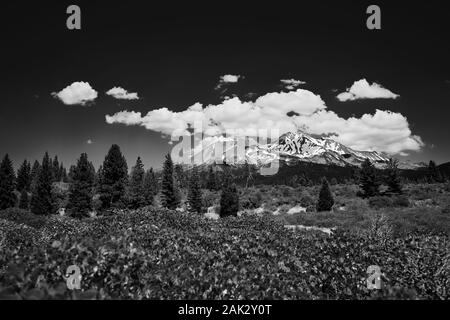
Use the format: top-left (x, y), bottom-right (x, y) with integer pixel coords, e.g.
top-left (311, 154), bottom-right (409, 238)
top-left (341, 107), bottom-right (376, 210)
top-left (0, 145), bottom-right (446, 219)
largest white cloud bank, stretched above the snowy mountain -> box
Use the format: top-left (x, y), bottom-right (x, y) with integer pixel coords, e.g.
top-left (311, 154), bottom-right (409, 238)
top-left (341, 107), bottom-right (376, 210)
top-left (106, 89), bottom-right (424, 154)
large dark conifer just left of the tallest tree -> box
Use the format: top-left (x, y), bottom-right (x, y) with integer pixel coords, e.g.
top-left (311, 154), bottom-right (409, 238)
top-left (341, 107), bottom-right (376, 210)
top-left (67, 153), bottom-right (95, 218)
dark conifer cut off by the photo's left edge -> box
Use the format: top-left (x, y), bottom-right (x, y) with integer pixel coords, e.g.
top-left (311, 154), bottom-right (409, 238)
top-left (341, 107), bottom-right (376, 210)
top-left (0, 155), bottom-right (17, 210)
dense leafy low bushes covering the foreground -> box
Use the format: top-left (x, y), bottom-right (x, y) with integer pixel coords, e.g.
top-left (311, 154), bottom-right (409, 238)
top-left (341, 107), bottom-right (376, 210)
top-left (0, 207), bottom-right (450, 299)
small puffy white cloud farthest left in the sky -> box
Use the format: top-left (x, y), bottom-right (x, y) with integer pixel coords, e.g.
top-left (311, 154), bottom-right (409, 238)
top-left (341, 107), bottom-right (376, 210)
top-left (52, 82), bottom-right (98, 106)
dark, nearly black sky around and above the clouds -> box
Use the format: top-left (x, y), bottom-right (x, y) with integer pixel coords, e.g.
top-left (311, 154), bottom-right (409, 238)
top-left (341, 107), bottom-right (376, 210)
top-left (0, 0), bottom-right (450, 167)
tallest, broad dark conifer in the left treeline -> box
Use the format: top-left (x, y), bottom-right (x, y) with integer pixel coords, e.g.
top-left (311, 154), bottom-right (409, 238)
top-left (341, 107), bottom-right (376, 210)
top-left (100, 144), bottom-right (128, 209)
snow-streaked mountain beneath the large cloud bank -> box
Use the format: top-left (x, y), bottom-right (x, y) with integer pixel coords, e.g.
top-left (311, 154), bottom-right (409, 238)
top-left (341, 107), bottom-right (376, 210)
top-left (188, 131), bottom-right (420, 169)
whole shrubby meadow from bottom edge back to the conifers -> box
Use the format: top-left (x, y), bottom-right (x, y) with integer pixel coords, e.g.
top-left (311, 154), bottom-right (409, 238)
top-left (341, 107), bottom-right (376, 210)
top-left (0, 184), bottom-right (450, 299)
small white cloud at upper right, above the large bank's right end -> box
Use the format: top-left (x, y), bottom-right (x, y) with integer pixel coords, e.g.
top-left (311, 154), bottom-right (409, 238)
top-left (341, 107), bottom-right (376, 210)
top-left (337, 79), bottom-right (400, 102)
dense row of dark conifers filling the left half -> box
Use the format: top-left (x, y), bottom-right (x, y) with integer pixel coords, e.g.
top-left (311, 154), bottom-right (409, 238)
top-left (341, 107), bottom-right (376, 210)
top-left (0, 145), bottom-right (243, 218)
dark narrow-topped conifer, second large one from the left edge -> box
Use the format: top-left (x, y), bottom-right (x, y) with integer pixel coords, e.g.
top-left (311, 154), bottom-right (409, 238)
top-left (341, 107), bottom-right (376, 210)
top-left (30, 152), bottom-right (56, 215)
